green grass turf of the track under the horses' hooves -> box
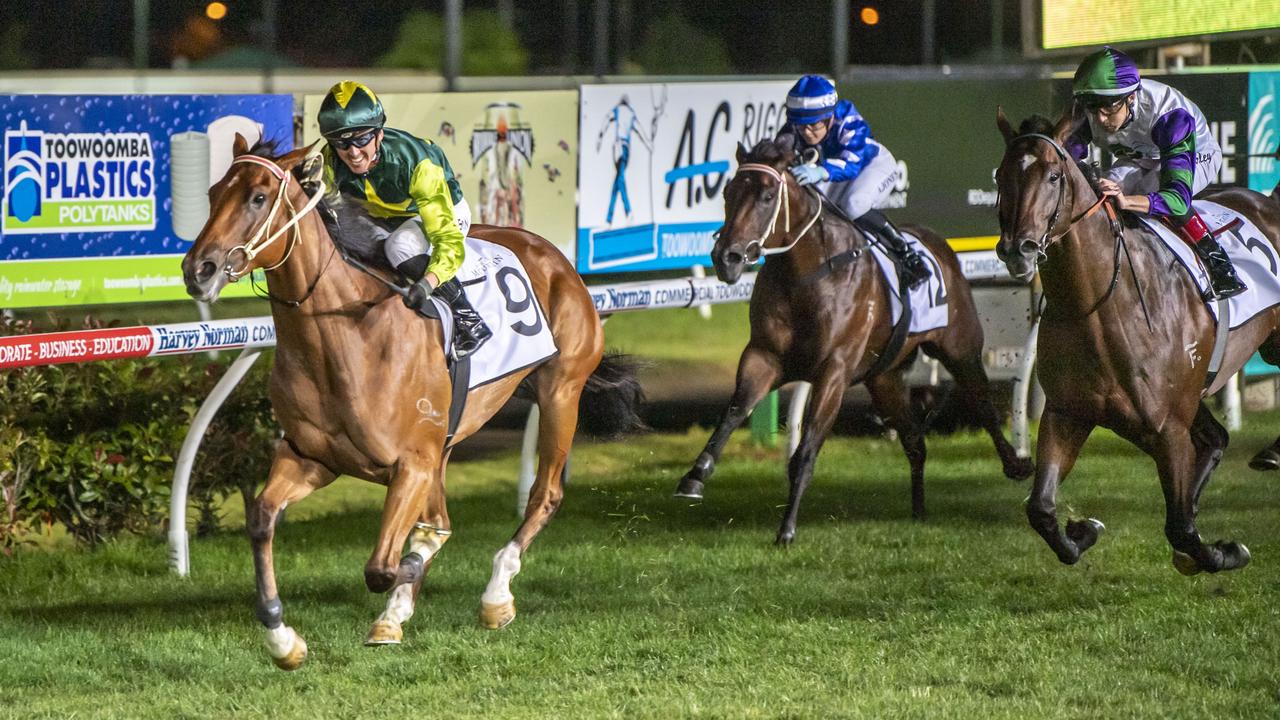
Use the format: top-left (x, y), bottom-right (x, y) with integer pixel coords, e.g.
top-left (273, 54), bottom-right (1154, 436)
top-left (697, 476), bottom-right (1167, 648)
top-left (0, 414), bottom-right (1280, 719)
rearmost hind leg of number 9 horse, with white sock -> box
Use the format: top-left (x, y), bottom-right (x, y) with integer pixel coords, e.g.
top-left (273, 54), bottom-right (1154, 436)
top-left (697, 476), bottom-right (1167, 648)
top-left (480, 361), bottom-right (582, 630)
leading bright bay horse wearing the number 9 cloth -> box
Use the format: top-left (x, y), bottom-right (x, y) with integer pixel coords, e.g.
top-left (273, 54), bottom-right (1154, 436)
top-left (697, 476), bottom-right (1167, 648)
top-left (182, 138), bottom-right (639, 669)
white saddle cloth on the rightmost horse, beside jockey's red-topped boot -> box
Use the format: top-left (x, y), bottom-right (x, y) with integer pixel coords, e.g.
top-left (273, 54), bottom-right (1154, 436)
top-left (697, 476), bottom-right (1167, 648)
top-left (1139, 200), bottom-right (1280, 329)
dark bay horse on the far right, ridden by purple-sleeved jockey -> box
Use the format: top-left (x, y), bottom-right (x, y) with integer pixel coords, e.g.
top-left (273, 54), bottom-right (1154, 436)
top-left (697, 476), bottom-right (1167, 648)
top-left (996, 110), bottom-right (1280, 575)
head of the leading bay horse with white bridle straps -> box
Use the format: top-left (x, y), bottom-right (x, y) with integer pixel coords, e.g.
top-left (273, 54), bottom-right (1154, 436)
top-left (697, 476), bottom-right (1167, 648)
top-left (182, 135), bottom-right (324, 302)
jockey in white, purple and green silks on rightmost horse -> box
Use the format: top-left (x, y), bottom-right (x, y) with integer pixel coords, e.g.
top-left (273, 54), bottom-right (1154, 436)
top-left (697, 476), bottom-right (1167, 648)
top-left (1066, 47), bottom-right (1247, 300)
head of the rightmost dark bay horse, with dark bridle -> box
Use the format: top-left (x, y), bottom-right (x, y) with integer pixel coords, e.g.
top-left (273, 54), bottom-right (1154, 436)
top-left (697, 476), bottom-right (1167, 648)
top-left (996, 109), bottom-right (1075, 281)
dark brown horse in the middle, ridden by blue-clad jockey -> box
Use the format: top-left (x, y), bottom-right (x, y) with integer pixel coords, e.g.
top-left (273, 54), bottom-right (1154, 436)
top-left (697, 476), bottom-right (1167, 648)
top-left (676, 137), bottom-right (1032, 544)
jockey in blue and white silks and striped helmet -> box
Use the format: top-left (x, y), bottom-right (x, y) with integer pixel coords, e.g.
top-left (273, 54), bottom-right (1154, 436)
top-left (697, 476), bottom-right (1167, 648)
top-left (778, 76), bottom-right (929, 287)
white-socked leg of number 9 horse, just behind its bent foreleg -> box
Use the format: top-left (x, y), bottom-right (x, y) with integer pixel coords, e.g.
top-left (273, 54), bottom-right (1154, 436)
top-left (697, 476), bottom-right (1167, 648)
top-left (365, 450), bottom-right (453, 646)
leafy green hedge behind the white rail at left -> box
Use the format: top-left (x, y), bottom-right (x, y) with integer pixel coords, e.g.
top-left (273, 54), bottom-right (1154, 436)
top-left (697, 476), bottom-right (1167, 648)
top-left (0, 319), bottom-right (276, 553)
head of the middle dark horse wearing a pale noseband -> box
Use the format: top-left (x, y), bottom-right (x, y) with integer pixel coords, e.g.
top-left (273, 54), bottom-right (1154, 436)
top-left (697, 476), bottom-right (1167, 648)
top-left (712, 136), bottom-right (803, 283)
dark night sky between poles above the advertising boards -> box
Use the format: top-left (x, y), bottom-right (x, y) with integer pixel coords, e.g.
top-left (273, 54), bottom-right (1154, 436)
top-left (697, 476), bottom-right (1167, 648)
top-left (0, 0), bottom-right (1019, 73)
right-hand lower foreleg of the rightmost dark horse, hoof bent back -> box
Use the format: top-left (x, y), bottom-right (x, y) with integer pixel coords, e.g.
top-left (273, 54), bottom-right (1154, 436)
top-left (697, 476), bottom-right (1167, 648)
top-left (1153, 417), bottom-right (1249, 575)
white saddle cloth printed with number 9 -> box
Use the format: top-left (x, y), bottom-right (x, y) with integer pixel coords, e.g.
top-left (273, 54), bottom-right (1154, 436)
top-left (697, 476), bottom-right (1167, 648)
top-left (431, 237), bottom-right (557, 389)
